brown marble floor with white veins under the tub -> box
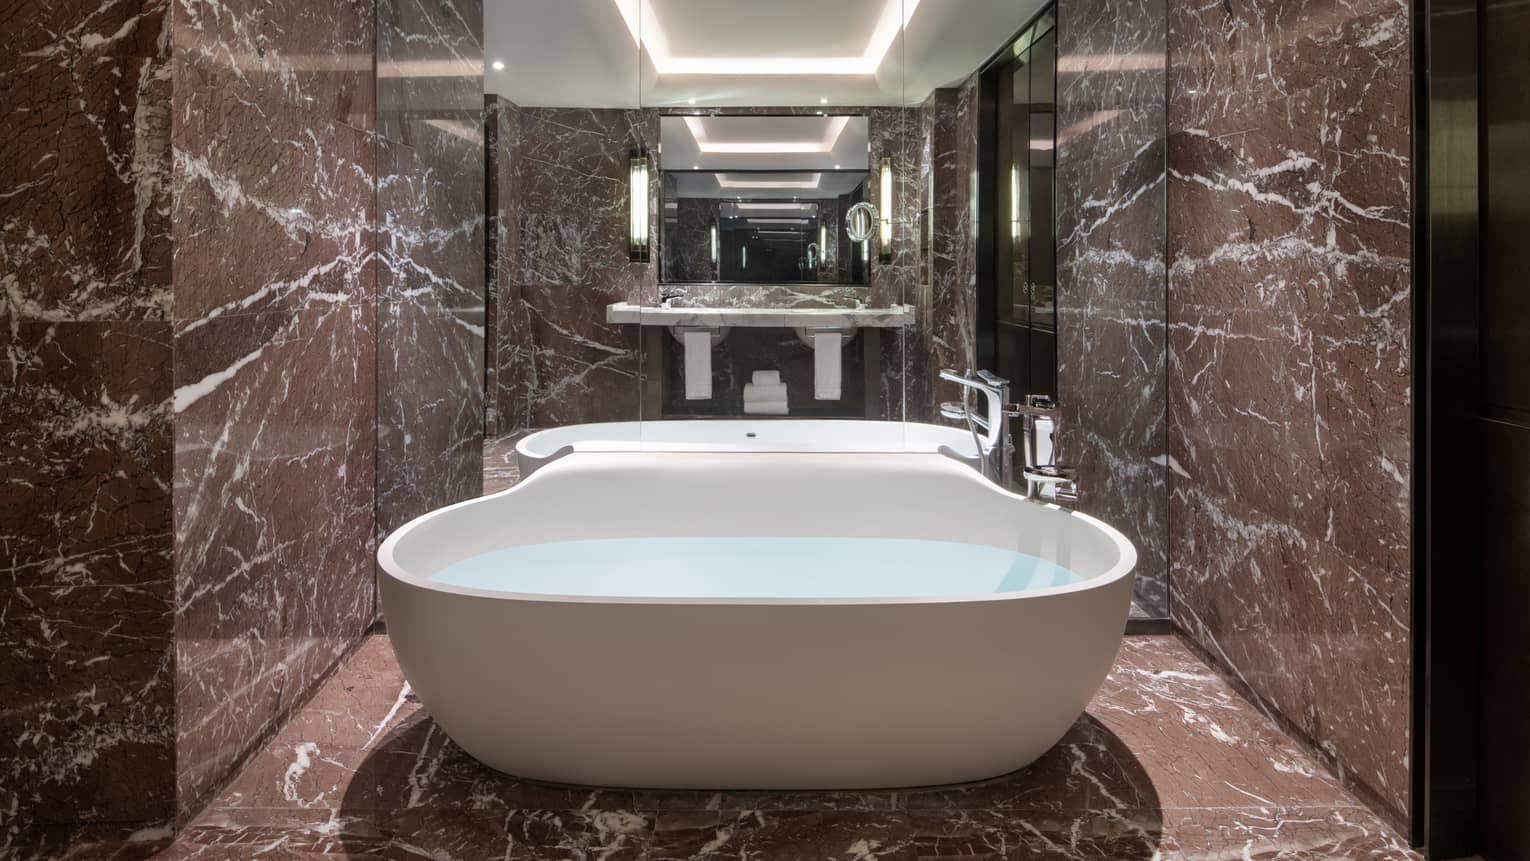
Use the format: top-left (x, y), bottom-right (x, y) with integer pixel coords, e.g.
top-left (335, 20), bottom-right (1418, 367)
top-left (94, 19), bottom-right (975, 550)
top-left (68, 635), bottom-right (1417, 861)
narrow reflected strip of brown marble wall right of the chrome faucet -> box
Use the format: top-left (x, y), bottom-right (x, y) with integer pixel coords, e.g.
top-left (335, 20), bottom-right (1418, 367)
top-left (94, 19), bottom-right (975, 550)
top-left (1056, 0), bottom-right (1169, 616)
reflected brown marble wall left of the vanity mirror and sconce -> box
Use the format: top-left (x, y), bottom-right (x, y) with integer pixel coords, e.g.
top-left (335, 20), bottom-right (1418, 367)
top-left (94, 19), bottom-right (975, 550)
top-left (494, 102), bottom-right (658, 433)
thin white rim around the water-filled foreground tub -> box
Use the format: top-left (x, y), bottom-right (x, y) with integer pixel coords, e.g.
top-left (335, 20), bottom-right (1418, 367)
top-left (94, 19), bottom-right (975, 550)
top-left (376, 451), bottom-right (1137, 607)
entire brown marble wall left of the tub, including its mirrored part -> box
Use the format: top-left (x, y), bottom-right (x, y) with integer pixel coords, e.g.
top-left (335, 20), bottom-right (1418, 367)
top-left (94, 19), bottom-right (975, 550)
top-left (0, 0), bottom-right (483, 847)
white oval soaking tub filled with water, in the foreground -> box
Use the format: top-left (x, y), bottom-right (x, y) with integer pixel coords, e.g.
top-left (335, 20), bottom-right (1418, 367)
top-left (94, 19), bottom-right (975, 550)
top-left (378, 453), bottom-right (1137, 789)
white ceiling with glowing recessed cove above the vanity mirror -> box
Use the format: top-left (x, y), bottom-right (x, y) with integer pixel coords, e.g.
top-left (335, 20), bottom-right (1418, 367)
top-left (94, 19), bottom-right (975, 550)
top-left (483, 0), bottom-right (1043, 109)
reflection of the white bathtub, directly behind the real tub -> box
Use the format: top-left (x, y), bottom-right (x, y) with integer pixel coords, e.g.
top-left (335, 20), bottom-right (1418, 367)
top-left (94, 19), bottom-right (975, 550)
top-left (516, 419), bottom-right (978, 477)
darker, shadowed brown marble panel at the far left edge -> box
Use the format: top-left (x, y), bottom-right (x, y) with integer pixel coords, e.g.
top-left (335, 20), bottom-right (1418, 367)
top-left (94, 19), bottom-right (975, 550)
top-left (0, 0), bottom-right (176, 838)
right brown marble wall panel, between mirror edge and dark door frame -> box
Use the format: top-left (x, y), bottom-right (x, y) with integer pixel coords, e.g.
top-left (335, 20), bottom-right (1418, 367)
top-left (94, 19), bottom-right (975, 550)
top-left (1167, 0), bottom-right (1411, 818)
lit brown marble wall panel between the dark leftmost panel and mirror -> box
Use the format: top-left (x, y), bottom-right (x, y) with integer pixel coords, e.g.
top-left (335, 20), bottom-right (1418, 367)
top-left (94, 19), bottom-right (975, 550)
top-left (171, 0), bottom-right (376, 812)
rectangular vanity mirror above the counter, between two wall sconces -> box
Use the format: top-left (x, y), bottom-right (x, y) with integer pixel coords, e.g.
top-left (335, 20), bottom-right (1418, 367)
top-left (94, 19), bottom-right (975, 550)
top-left (659, 112), bottom-right (869, 284)
